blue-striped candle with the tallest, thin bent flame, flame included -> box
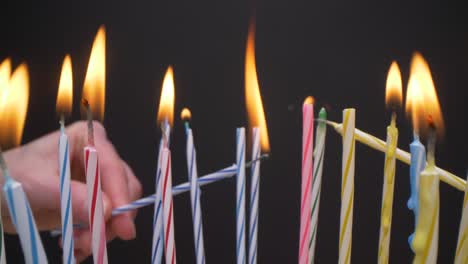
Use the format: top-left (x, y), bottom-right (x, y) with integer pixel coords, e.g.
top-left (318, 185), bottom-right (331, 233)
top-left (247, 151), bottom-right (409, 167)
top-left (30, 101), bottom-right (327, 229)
top-left (245, 22), bottom-right (270, 264)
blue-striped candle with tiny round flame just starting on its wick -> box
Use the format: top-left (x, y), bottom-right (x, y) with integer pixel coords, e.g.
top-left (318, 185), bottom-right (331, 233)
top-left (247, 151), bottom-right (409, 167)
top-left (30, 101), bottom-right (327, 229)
top-left (181, 108), bottom-right (205, 264)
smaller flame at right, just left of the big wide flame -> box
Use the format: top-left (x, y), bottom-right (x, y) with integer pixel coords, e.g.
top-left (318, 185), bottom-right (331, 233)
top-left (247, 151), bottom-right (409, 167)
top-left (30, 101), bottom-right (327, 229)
top-left (385, 61), bottom-right (403, 110)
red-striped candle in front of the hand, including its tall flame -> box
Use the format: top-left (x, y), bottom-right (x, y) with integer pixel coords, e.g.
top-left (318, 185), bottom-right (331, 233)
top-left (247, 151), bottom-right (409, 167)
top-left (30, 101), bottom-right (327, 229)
top-left (83, 26), bottom-right (108, 264)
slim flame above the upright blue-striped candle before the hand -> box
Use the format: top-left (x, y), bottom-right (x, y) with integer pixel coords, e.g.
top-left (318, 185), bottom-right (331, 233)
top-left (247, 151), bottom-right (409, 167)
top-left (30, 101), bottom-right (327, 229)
top-left (56, 55), bottom-right (73, 116)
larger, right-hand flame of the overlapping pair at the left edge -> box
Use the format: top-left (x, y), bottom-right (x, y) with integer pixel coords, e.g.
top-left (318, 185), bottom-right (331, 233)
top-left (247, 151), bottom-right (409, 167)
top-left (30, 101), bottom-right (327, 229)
top-left (0, 63), bottom-right (29, 148)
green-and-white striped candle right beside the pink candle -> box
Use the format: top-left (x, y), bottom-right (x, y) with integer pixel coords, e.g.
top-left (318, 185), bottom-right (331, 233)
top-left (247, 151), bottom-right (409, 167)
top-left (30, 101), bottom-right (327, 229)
top-left (309, 108), bottom-right (327, 263)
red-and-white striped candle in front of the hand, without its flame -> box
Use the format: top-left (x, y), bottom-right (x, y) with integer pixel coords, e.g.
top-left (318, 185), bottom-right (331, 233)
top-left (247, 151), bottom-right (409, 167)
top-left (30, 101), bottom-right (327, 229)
top-left (84, 146), bottom-right (107, 264)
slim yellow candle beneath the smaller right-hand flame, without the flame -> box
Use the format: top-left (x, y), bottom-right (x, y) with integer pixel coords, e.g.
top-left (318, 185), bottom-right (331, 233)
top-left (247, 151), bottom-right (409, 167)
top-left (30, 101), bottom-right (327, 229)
top-left (378, 114), bottom-right (398, 264)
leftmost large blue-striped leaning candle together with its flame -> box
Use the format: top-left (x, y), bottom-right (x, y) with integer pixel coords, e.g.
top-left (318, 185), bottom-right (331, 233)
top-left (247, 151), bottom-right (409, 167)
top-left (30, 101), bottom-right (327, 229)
top-left (0, 64), bottom-right (48, 264)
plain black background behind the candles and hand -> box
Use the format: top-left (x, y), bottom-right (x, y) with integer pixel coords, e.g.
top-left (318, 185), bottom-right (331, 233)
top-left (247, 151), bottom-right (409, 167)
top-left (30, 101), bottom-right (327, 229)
top-left (0, 0), bottom-right (468, 263)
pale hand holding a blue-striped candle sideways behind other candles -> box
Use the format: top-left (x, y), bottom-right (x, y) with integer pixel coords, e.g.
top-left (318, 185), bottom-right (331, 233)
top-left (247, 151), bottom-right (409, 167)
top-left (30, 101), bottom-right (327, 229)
top-left (0, 121), bottom-right (142, 262)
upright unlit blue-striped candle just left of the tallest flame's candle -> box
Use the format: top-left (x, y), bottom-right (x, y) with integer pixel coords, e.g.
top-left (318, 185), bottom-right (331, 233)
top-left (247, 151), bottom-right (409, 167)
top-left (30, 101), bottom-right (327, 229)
top-left (236, 127), bottom-right (246, 264)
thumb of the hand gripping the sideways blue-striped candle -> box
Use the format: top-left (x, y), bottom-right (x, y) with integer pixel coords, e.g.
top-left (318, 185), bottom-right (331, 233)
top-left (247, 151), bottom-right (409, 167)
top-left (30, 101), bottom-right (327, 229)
top-left (71, 180), bottom-right (112, 224)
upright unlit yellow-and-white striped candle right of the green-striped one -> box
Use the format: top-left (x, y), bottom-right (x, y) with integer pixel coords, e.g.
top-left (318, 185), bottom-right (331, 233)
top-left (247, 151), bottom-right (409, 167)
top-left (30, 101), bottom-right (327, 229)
top-left (338, 108), bottom-right (355, 263)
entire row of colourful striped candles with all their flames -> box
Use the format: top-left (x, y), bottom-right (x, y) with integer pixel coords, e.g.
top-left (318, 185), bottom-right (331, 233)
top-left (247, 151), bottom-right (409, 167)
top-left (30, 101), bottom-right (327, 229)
top-left (0, 20), bottom-right (468, 263)
